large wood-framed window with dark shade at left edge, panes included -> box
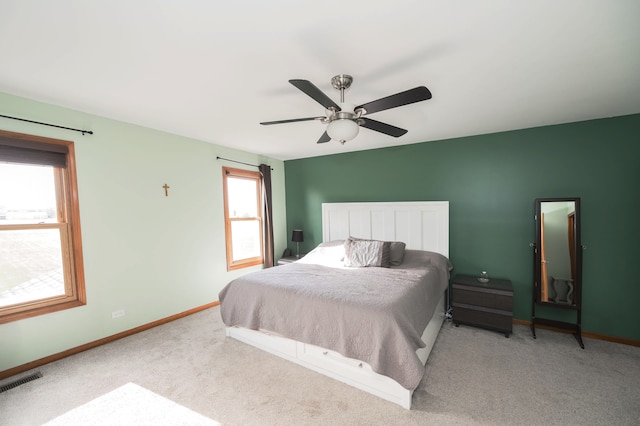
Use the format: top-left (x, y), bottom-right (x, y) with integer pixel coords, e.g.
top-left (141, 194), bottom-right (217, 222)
top-left (0, 131), bottom-right (86, 323)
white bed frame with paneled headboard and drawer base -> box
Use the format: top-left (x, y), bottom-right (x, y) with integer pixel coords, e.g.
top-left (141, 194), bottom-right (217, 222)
top-left (226, 201), bottom-right (449, 409)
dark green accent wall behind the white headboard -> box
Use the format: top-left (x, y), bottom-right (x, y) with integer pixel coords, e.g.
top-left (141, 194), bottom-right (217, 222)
top-left (285, 115), bottom-right (640, 340)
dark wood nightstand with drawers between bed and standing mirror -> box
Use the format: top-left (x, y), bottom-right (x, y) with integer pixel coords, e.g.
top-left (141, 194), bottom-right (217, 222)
top-left (451, 275), bottom-right (513, 337)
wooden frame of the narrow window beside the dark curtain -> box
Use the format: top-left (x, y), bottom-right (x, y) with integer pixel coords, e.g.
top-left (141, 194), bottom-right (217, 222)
top-left (222, 167), bottom-right (264, 271)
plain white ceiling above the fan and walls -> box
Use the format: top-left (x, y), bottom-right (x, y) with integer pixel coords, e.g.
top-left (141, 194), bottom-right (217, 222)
top-left (0, 0), bottom-right (640, 160)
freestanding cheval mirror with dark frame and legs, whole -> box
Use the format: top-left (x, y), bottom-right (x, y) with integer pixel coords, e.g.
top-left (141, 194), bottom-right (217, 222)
top-left (531, 198), bottom-right (584, 349)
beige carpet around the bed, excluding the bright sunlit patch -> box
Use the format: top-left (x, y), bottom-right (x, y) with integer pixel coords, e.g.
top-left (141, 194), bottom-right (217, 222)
top-left (0, 307), bottom-right (640, 426)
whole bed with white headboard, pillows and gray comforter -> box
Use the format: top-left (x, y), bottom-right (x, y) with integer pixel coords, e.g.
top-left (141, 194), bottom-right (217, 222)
top-left (220, 202), bottom-right (451, 409)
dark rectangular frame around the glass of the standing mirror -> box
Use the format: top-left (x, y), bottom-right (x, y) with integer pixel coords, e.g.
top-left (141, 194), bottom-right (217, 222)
top-left (533, 197), bottom-right (582, 310)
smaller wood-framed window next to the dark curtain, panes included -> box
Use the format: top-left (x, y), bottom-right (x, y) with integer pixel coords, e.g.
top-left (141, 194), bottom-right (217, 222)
top-left (222, 167), bottom-right (264, 271)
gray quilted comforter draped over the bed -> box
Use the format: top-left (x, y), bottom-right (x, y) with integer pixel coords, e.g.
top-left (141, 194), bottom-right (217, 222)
top-left (219, 250), bottom-right (451, 390)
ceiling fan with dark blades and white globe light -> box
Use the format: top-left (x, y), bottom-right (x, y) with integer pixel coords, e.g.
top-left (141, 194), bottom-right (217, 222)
top-left (260, 74), bottom-right (431, 144)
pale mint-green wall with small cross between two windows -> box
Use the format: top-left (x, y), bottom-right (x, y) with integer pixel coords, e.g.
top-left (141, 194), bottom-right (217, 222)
top-left (0, 93), bottom-right (286, 371)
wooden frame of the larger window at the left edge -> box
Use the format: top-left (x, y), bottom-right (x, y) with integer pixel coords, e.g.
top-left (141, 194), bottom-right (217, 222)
top-left (0, 130), bottom-right (87, 324)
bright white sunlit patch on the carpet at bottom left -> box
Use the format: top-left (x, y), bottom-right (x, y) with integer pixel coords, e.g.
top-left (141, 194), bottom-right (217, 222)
top-left (45, 383), bottom-right (220, 426)
